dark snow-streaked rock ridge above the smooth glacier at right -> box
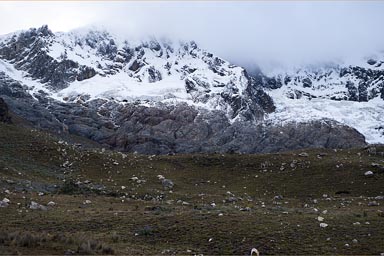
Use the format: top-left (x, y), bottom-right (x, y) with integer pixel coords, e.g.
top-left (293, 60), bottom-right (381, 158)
top-left (252, 62), bottom-right (384, 102)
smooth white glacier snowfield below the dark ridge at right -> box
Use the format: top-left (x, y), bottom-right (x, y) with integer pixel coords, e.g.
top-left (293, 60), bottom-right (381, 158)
top-left (266, 87), bottom-right (384, 143)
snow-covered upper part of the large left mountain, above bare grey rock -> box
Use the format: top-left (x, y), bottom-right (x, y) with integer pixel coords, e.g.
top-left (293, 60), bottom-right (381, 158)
top-left (0, 26), bottom-right (273, 122)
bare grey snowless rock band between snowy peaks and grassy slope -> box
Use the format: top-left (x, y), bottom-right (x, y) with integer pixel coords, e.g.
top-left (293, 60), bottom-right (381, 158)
top-left (0, 73), bottom-right (365, 154)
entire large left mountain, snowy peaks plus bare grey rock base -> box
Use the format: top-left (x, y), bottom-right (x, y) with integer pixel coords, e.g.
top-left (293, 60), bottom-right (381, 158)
top-left (0, 26), bottom-right (365, 154)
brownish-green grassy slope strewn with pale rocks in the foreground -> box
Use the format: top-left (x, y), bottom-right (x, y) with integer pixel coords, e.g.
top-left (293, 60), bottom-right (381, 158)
top-left (0, 124), bottom-right (384, 255)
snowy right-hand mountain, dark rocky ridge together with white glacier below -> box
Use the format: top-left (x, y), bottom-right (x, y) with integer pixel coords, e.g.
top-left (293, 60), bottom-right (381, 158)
top-left (249, 57), bottom-right (384, 143)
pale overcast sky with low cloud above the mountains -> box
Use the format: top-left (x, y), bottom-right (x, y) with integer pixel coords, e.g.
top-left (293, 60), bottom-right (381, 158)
top-left (0, 1), bottom-right (384, 68)
